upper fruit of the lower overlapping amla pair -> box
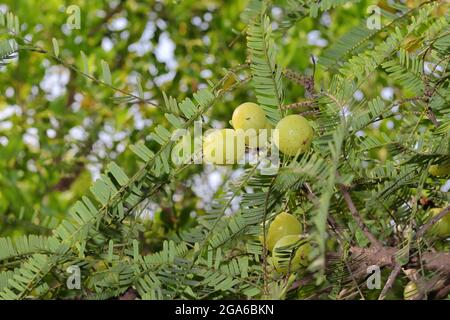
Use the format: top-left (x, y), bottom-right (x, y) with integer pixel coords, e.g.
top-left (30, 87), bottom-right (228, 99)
top-left (266, 212), bottom-right (302, 251)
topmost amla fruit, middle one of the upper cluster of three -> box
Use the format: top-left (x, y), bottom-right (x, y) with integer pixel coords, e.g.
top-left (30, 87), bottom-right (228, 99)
top-left (231, 102), bottom-right (267, 131)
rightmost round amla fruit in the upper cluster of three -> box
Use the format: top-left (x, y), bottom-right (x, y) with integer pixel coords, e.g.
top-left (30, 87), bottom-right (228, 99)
top-left (275, 114), bottom-right (314, 156)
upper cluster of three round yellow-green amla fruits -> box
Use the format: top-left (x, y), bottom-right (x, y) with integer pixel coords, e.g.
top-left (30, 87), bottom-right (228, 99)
top-left (203, 102), bottom-right (314, 165)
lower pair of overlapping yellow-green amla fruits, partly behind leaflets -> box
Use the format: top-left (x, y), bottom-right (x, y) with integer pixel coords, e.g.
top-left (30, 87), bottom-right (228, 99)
top-left (260, 212), bottom-right (312, 274)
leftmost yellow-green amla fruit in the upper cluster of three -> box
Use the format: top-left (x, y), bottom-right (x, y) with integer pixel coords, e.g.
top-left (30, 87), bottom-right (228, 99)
top-left (203, 129), bottom-right (245, 165)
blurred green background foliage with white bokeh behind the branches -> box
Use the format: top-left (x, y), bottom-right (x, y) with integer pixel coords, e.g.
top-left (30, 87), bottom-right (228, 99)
top-left (0, 0), bottom-right (444, 250)
